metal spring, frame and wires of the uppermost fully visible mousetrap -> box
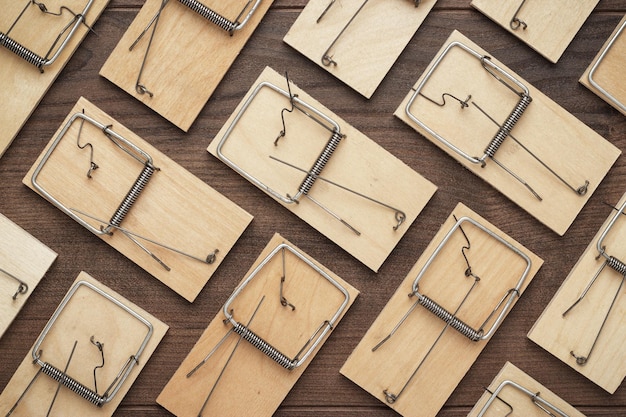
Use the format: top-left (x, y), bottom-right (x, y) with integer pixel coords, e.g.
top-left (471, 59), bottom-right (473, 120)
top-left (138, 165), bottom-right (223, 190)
top-left (405, 42), bottom-right (589, 201)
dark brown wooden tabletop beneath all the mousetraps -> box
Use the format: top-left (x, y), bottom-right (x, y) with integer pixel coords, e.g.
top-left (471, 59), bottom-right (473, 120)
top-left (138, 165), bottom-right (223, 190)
top-left (0, 0), bottom-right (626, 417)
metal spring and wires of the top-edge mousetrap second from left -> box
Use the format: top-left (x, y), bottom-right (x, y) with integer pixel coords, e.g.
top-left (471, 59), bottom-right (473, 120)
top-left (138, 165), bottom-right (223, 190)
top-left (128, 0), bottom-right (261, 97)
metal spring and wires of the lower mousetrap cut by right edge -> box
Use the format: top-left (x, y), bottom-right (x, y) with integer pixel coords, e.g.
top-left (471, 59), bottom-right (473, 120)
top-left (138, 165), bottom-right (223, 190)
top-left (563, 203), bottom-right (626, 366)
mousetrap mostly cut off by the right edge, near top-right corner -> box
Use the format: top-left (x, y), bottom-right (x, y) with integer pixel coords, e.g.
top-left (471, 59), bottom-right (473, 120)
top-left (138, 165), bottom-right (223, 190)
top-left (579, 15), bottom-right (626, 115)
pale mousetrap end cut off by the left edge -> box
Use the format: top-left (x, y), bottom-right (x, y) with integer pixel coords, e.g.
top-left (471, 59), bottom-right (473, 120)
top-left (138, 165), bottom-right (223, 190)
top-left (0, 214), bottom-right (57, 337)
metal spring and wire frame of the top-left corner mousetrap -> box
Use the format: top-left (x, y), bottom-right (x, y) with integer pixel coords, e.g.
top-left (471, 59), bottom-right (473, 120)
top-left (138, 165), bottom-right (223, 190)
top-left (0, 0), bottom-right (93, 72)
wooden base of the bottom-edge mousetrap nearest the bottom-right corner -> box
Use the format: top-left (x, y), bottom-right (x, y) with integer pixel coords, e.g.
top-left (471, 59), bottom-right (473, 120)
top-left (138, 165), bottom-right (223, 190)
top-left (467, 362), bottom-right (585, 417)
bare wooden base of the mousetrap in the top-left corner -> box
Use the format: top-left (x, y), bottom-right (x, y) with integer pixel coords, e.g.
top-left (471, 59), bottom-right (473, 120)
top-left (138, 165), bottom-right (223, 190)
top-left (0, 0), bottom-right (109, 156)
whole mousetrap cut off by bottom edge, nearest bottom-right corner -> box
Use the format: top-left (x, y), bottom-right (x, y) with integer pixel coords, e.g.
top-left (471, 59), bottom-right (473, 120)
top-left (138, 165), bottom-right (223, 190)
top-left (467, 362), bottom-right (585, 417)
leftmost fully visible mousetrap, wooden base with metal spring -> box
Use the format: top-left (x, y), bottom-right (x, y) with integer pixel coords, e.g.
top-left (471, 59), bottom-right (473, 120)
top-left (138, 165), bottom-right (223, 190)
top-left (23, 98), bottom-right (252, 302)
